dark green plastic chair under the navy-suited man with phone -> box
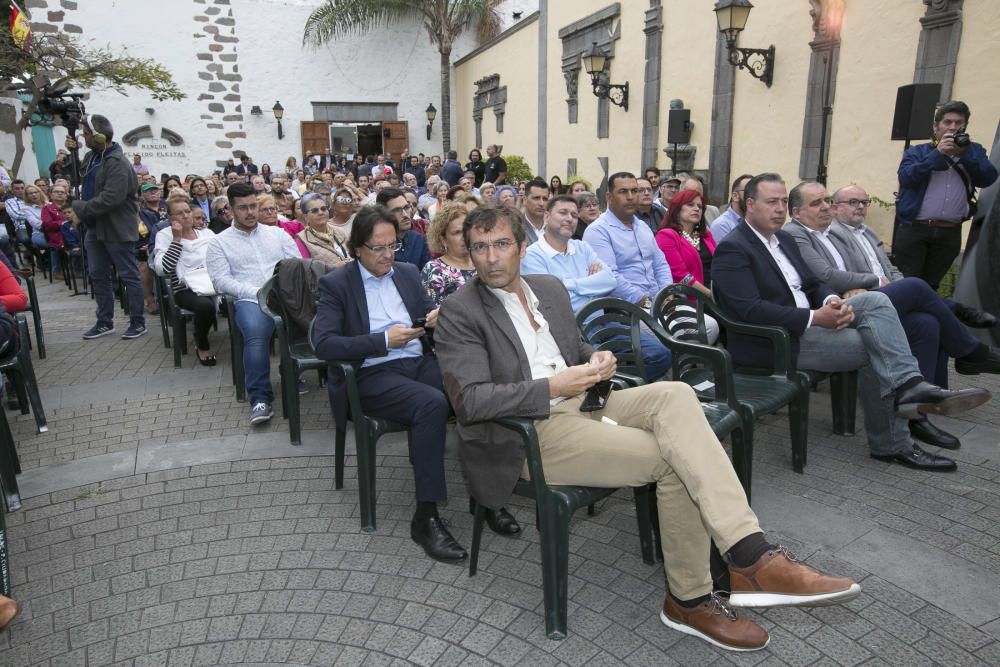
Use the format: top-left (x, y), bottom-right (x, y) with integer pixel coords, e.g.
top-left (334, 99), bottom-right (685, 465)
top-left (309, 318), bottom-right (412, 533)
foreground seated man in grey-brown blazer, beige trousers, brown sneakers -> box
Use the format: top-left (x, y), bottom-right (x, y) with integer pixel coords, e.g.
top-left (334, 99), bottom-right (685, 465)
top-left (435, 205), bottom-right (861, 651)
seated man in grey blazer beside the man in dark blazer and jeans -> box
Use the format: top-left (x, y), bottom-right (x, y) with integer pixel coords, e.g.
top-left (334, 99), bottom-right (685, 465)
top-left (784, 182), bottom-right (1000, 449)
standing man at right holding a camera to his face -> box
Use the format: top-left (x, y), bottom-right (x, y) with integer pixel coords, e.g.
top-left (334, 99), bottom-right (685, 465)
top-left (893, 100), bottom-right (997, 289)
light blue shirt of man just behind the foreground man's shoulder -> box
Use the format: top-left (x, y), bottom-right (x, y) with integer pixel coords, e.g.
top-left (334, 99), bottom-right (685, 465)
top-left (521, 236), bottom-right (617, 312)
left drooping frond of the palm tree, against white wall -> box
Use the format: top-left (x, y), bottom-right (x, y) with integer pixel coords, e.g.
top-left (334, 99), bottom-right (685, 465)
top-left (302, 0), bottom-right (430, 46)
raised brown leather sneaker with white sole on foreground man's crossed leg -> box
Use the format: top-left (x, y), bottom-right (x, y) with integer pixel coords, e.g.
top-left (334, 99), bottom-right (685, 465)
top-left (729, 546), bottom-right (861, 607)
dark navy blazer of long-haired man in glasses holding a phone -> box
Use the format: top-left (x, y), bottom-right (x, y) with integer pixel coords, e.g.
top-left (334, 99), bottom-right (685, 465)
top-left (313, 261), bottom-right (434, 429)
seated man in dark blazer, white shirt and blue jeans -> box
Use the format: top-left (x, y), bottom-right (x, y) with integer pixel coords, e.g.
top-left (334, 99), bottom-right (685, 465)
top-left (712, 173), bottom-right (990, 470)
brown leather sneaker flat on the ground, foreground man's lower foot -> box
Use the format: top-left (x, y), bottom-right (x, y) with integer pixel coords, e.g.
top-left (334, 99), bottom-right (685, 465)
top-left (660, 593), bottom-right (771, 651)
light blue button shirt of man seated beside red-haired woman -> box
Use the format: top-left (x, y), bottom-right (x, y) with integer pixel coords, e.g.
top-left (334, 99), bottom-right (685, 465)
top-left (583, 209), bottom-right (673, 303)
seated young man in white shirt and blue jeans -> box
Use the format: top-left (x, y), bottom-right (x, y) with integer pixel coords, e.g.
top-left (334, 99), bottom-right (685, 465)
top-left (205, 183), bottom-right (302, 425)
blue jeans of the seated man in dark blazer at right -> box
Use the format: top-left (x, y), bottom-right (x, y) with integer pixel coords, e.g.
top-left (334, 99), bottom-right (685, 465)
top-left (798, 292), bottom-right (921, 456)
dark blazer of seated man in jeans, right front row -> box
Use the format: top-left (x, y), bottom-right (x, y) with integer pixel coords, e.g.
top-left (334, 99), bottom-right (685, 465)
top-left (712, 223), bottom-right (835, 367)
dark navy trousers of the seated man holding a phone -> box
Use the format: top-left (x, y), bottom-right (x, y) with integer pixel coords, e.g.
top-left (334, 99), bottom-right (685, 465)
top-left (358, 354), bottom-right (448, 502)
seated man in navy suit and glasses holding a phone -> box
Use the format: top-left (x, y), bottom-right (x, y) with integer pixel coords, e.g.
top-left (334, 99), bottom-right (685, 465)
top-left (313, 206), bottom-right (520, 562)
